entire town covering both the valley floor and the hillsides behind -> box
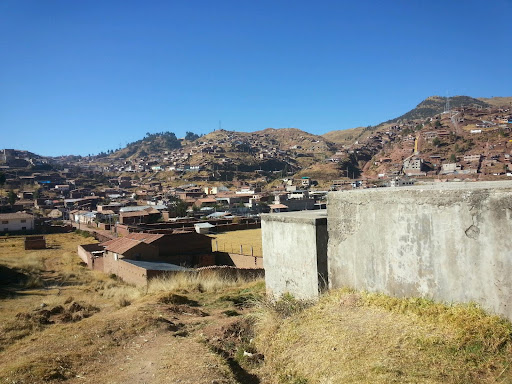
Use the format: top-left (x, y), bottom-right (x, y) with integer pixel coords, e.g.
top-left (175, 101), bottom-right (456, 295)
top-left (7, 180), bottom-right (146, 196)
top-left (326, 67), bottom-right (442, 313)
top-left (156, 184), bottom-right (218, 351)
top-left (0, 99), bottom-right (512, 226)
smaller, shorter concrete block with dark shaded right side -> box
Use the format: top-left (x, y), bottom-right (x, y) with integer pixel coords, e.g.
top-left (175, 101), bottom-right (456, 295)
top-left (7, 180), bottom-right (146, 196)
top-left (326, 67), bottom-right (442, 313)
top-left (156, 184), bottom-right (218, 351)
top-left (261, 210), bottom-right (327, 298)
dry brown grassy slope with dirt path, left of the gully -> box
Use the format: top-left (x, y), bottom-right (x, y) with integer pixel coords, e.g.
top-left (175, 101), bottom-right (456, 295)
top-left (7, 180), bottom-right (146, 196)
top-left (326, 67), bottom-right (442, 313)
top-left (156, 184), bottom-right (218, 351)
top-left (0, 234), bottom-right (264, 383)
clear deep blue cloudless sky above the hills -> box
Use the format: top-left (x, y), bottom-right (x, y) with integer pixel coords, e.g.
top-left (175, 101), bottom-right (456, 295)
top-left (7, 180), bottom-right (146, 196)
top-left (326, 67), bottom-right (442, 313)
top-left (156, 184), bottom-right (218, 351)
top-left (0, 0), bottom-right (512, 155)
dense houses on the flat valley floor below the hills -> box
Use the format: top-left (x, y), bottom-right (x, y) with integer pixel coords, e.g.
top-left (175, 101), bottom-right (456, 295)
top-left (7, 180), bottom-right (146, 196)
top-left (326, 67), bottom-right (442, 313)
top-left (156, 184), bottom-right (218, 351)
top-left (0, 148), bottom-right (326, 232)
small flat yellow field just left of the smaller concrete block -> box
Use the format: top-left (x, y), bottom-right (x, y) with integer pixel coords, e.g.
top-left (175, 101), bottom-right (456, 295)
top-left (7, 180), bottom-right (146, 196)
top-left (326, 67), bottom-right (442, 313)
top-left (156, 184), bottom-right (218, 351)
top-left (210, 229), bottom-right (263, 256)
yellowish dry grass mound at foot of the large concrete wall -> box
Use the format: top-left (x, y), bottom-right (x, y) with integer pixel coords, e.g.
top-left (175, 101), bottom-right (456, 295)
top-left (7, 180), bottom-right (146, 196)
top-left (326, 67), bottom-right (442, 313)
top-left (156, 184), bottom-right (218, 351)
top-left (257, 291), bottom-right (512, 383)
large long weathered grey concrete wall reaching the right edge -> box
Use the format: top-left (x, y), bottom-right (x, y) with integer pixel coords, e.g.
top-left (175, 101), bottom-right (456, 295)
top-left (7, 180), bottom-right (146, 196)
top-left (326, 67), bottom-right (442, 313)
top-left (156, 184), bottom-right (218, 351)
top-left (328, 181), bottom-right (512, 319)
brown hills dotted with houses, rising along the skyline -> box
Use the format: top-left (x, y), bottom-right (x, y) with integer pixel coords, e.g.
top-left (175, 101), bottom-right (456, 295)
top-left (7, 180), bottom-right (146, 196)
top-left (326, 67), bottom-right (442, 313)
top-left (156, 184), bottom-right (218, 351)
top-left (0, 96), bottom-right (512, 187)
